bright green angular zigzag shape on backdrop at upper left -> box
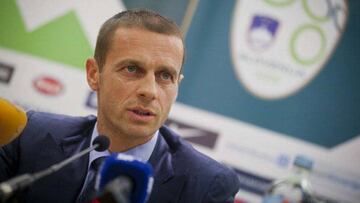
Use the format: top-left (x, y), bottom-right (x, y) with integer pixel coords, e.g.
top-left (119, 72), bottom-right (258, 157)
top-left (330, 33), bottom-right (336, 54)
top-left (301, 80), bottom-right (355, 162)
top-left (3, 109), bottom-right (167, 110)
top-left (0, 0), bottom-right (93, 69)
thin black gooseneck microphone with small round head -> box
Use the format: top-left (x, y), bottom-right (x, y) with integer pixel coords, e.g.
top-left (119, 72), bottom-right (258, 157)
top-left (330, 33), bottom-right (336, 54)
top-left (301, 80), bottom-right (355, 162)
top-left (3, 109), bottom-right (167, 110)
top-left (0, 135), bottom-right (110, 202)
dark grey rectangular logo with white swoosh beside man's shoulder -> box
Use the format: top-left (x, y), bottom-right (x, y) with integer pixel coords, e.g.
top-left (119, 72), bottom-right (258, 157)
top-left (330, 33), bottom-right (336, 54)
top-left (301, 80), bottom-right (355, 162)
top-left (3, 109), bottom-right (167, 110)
top-left (166, 119), bottom-right (219, 149)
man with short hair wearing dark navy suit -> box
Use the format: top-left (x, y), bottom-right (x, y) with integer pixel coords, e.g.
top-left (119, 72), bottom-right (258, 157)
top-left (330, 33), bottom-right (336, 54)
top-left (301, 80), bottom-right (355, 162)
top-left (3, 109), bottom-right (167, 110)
top-left (0, 10), bottom-right (239, 202)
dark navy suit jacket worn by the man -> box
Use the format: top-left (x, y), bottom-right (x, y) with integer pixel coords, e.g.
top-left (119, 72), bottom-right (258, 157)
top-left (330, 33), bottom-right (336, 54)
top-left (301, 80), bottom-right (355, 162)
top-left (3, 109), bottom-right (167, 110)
top-left (0, 112), bottom-right (239, 203)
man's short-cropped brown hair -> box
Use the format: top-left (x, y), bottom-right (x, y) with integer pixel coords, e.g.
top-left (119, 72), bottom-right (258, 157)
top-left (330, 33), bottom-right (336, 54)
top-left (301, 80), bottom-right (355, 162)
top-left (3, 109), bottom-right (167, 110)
top-left (94, 10), bottom-right (185, 71)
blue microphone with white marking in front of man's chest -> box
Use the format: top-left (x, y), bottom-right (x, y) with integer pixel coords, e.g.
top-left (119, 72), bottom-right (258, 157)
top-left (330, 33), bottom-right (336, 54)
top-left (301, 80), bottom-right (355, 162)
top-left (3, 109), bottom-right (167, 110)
top-left (96, 154), bottom-right (154, 203)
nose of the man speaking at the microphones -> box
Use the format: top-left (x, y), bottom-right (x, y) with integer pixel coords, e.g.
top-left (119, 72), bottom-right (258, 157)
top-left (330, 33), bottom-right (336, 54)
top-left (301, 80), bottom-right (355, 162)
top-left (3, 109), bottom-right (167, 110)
top-left (138, 74), bottom-right (158, 101)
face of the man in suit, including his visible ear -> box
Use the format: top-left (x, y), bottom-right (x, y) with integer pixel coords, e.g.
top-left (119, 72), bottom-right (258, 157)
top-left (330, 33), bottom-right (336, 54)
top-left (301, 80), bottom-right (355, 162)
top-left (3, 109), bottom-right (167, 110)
top-left (87, 28), bottom-right (184, 143)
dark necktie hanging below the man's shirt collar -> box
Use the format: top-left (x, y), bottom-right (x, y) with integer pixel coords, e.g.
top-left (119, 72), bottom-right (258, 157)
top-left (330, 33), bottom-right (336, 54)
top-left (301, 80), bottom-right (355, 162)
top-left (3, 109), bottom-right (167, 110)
top-left (77, 157), bottom-right (106, 203)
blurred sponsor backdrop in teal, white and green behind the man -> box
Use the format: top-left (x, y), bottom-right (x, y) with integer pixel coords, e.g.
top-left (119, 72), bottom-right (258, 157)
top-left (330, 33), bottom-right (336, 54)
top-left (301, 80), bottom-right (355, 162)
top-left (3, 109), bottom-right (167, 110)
top-left (0, 0), bottom-right (360, 202)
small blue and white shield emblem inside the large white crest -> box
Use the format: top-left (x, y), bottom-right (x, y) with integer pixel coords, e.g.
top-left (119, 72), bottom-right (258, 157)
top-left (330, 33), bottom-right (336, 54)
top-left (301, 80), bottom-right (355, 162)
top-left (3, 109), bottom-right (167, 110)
top-left (247, 15), bottom-right (279, 51)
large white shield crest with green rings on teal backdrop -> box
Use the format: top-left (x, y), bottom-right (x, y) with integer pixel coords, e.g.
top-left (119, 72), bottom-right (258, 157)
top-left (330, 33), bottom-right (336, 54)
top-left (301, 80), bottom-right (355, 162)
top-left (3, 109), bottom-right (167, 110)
top-left (231, 0), bottom-right (348, 99)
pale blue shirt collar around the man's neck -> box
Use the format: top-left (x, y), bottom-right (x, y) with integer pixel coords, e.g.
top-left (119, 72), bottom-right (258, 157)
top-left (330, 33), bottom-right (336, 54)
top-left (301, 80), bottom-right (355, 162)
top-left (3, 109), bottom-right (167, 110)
top-left (88, 122), bottom-right (159, 167)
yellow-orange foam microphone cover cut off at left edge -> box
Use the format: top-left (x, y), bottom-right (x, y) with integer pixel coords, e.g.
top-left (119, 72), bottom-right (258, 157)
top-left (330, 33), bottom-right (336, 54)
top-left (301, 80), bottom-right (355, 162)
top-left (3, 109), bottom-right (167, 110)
top-left (0, 98), bottom-right (27, 147)
